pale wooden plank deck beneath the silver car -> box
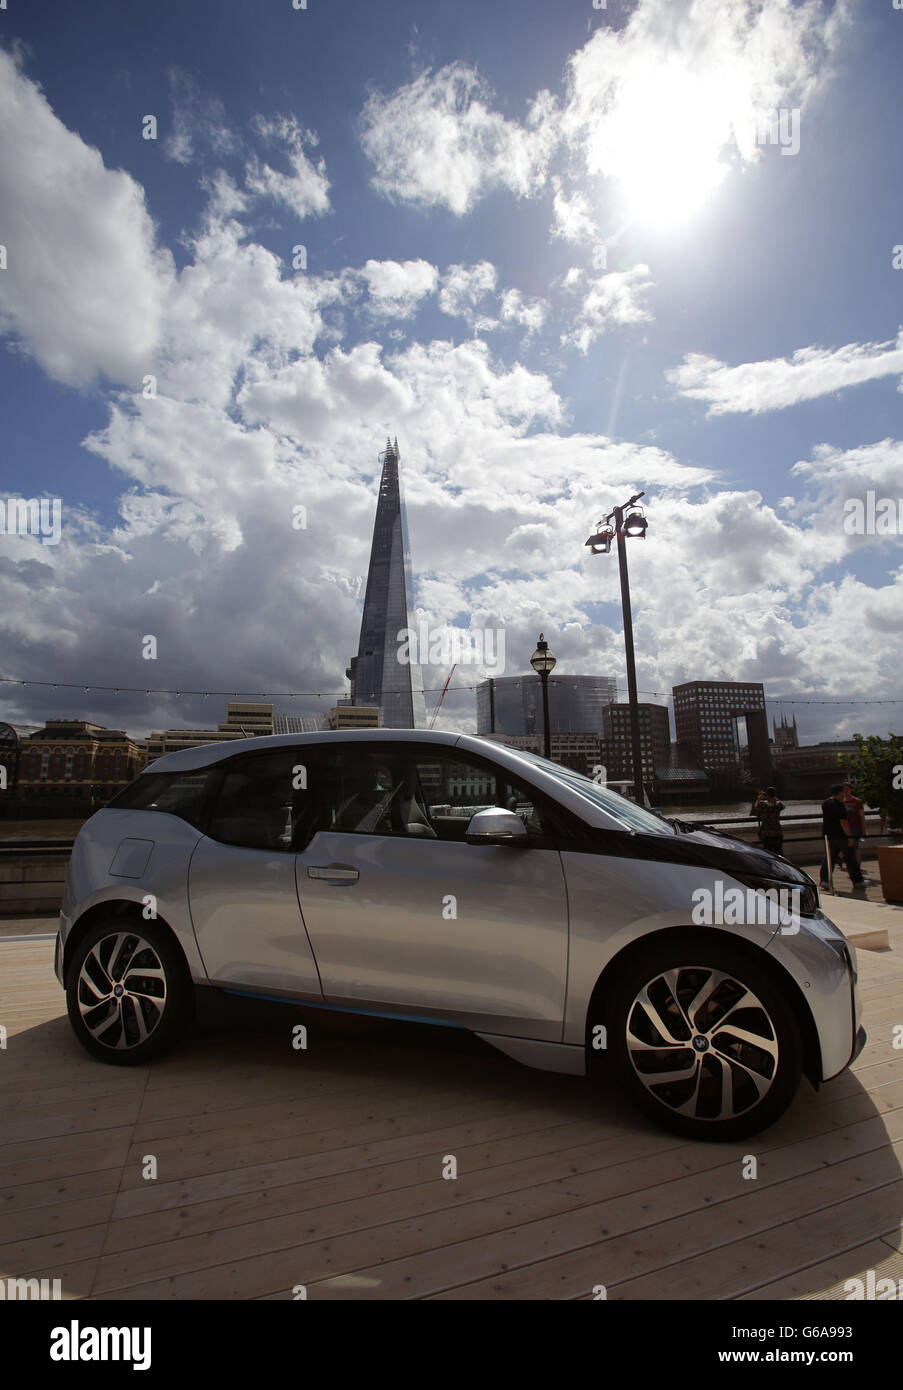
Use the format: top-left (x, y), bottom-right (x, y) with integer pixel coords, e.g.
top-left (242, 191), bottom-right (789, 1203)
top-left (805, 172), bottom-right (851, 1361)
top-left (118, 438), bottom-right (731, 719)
top-left (0, 927), bottom-right (903, 1300)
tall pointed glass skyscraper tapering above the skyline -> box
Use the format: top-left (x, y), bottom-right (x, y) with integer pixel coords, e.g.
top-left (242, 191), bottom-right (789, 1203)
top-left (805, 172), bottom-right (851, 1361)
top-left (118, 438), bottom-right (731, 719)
top-left (345, 439), bottom-right (426, 728)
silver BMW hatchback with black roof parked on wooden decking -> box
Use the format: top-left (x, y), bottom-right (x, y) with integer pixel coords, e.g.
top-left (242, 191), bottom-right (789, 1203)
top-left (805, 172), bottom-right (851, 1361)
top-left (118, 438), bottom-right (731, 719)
top-left (56, 730), bottom-right (865, 1140)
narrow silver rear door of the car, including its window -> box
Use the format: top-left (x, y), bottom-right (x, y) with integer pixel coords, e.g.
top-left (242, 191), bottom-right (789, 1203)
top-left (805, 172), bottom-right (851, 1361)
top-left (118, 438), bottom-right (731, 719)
top-left (188, 748), bottom-right (322, 999)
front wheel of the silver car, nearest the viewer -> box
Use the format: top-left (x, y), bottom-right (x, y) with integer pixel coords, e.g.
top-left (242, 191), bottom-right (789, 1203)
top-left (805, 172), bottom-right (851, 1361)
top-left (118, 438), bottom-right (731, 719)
top-left (592, 937), bottom-right (803, 1141)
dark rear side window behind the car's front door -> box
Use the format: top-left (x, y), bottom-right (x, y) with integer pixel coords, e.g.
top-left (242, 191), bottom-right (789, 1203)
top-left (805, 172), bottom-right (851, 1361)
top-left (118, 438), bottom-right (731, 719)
top-left (207, 748), bottom-right (314, 851)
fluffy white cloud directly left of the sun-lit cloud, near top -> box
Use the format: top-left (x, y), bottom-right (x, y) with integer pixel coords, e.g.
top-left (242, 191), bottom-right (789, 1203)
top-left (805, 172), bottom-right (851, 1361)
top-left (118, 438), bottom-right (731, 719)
top-left (361, 63), bottom-right (557, 215)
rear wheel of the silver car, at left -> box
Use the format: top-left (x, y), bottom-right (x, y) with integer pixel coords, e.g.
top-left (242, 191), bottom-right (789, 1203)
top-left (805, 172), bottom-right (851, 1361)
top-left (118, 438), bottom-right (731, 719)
top-left (65, 917), bottom-right (194, 1066)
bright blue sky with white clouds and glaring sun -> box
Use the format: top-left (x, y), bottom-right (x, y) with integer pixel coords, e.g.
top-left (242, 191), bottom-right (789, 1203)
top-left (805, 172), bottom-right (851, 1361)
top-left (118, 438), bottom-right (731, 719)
top-left (0, 0), bottom-right (903, 742)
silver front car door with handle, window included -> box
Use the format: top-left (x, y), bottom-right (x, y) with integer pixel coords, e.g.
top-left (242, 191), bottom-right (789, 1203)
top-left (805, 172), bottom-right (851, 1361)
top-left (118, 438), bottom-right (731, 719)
top-left (296, 741), bottom-right (568, 1041)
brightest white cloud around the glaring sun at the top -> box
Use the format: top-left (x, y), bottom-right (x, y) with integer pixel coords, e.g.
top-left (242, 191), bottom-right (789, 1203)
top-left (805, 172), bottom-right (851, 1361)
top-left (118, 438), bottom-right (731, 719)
top-left (561, 0), bottom-right (847, 224)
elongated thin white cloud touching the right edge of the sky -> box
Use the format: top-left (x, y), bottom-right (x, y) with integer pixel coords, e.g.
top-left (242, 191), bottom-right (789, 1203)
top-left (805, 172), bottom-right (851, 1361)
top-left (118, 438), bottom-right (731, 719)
top-left (665, 332), bottom-right (903, 416)
